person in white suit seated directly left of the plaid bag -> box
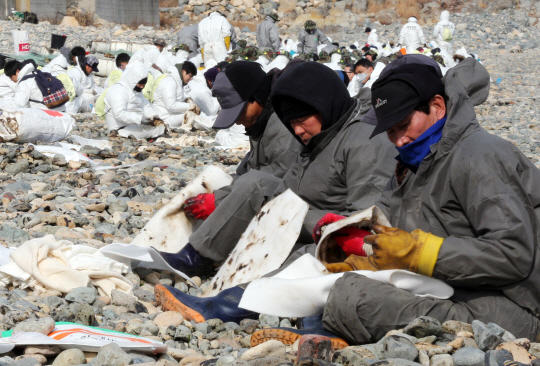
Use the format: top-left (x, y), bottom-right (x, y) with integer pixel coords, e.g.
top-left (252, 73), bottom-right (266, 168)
top-left (4, 60), bottom-right (66, 112)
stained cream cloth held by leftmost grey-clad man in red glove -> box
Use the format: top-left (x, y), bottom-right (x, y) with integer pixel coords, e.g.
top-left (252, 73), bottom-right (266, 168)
top-left (131, 166), bottom-right (233, 253)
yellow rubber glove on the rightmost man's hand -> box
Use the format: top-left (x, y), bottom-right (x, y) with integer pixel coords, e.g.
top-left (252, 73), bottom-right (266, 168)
top-left (364, 225), bottom-right (444, 277)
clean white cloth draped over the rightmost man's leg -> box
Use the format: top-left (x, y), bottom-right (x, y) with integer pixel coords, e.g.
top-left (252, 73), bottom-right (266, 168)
top-left (239, 254), bottom-right (454, 317)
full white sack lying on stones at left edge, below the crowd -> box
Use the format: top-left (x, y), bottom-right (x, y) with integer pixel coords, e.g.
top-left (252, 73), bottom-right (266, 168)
top-left (0, 108), bottom-right (75, 143)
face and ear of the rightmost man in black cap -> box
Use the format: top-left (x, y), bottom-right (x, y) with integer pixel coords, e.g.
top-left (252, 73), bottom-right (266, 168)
top-left (386, 95), bottom-right (446, 147)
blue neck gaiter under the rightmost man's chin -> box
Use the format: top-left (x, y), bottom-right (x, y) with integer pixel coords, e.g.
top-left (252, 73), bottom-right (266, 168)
top-left (396, 116), bottom-right (446, 173)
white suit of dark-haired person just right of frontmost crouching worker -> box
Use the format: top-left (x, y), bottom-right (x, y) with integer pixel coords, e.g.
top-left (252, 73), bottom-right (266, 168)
top-left (152, 55), bottom-right (190, 128)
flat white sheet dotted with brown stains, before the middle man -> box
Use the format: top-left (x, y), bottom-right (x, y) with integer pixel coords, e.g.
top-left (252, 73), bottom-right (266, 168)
top-left (203, 189), bottom-right (309, 296)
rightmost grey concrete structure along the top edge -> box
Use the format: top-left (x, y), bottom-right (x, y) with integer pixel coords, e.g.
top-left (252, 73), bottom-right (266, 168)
top-left (95, 0), bottom-right (159, 26)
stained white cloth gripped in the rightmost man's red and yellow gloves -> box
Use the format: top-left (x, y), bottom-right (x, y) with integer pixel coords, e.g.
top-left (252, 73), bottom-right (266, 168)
top-left (315, 206), bottom-right (392, 264)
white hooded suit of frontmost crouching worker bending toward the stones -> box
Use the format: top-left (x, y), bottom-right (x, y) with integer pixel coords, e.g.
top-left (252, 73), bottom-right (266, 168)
top-left (105, 62), bottom-right (165, 139)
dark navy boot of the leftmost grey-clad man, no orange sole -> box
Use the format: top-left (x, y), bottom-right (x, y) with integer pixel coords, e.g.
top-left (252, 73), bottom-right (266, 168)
top-left (159, 243), bottom-right (214, 277)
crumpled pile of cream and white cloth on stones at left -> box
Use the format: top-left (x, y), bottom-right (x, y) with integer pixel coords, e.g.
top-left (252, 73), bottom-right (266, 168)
top-left (0, 235), bottom-right (132, 297)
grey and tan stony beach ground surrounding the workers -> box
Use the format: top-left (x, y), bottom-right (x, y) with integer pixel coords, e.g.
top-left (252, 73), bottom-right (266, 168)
top-left (0, 0), bottom-right (540, 366)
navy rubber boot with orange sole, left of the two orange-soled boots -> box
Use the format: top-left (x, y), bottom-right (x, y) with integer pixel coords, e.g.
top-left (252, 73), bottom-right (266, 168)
top-left (154, 285), bottom-right (259, 323)
